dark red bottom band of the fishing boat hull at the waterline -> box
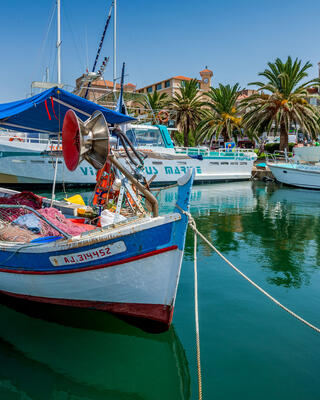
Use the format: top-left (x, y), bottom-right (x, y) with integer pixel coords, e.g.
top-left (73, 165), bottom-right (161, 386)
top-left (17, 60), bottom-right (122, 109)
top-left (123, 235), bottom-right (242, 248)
top-left (0, 290), bottom-right (173, 328)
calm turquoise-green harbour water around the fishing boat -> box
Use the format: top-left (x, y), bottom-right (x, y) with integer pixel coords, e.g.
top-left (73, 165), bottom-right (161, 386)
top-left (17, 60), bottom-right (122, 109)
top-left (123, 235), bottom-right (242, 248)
top-left (0, 182), bottom-right (320, 400)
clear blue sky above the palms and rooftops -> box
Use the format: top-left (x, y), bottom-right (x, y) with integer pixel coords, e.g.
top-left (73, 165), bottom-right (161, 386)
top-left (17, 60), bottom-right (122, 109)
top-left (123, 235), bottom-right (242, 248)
top-left (0, 0), bottom-right (320, 102)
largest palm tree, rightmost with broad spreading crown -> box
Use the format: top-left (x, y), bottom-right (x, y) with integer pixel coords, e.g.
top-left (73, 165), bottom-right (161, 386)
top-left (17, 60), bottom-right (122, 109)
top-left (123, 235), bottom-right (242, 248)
top-left (241, 57), bottom-right (320, 150)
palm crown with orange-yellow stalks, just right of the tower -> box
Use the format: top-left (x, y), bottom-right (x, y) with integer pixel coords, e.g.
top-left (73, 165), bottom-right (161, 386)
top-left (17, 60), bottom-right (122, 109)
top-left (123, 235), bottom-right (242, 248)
top-left (197, 83), bottom-right (242, 143)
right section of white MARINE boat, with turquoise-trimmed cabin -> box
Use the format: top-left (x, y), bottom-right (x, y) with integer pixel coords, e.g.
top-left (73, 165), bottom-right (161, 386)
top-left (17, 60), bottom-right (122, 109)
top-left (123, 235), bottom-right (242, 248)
top-left (121, 124), bottom-right (257, 185)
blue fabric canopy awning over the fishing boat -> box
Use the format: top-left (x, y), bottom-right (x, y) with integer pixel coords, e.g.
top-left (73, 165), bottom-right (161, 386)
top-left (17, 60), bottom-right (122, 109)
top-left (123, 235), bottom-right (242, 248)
top-left (0, 87), bottom-right (134, 133)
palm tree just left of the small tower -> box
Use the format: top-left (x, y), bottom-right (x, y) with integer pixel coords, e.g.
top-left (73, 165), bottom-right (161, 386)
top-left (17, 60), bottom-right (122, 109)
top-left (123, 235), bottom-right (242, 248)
top-left (170, 79), bottom-right (202, 147)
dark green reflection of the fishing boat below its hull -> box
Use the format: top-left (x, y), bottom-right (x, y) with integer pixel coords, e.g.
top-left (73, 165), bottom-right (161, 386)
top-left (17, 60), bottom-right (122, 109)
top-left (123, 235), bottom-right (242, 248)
top-left (0, 296), bottom-right (190, 400)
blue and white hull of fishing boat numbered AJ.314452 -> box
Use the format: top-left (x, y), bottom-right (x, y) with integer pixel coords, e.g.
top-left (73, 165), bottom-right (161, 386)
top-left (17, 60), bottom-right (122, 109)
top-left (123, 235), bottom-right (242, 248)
top-left (0, 170), bottom-right (193, 327)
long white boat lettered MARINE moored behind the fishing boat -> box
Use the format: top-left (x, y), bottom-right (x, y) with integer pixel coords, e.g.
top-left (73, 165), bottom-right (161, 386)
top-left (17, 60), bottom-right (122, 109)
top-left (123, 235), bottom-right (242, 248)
top-left (0, 124), bottom-right (256, 185)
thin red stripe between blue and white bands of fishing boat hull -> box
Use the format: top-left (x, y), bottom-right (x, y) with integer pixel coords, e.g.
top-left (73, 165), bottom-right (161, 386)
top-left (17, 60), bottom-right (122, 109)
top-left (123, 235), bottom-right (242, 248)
top-left (0, 246), bottom-right (178, 275)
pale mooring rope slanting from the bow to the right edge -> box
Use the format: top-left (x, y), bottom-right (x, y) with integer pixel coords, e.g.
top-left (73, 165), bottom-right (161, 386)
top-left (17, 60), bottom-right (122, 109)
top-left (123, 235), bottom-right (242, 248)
top-left (176, 205), bottom-right (320, 333)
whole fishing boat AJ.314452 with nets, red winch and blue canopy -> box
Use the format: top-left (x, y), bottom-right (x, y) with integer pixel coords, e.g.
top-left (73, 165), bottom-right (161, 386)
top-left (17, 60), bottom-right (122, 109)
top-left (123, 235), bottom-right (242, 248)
top-left (0, 87), bottom-right (194, 329)
